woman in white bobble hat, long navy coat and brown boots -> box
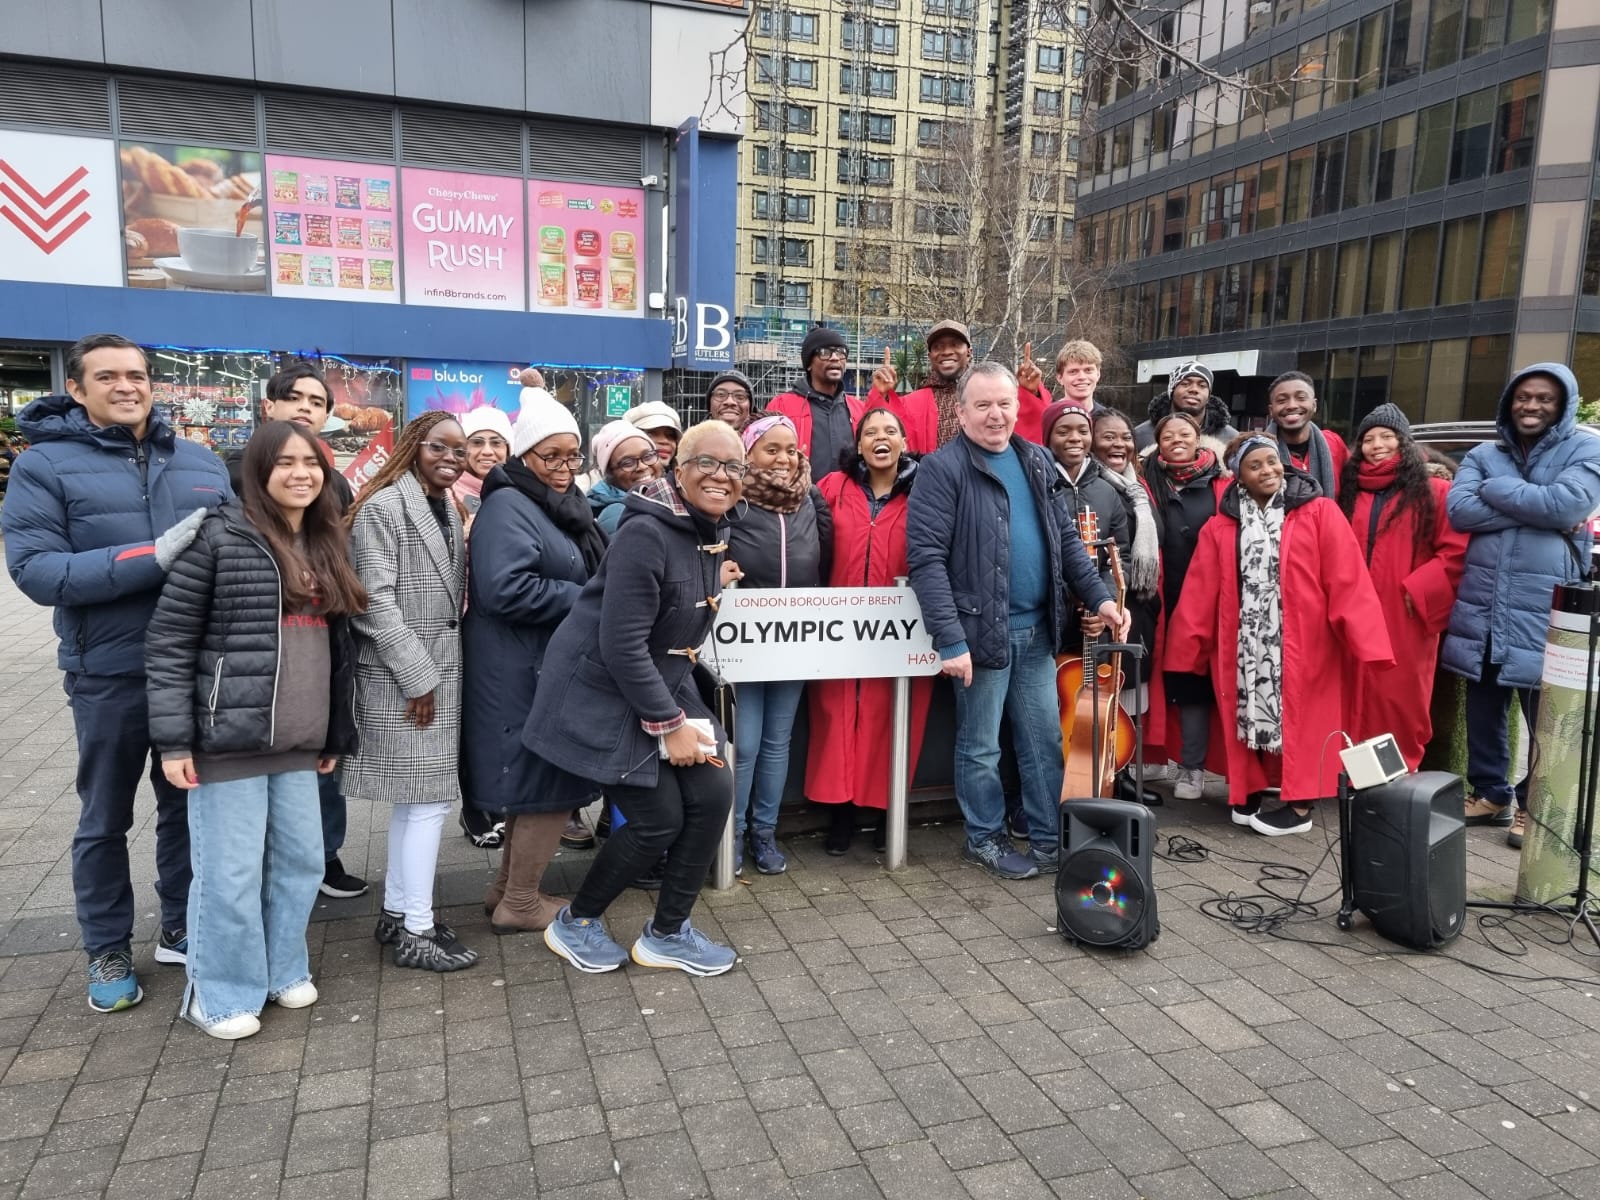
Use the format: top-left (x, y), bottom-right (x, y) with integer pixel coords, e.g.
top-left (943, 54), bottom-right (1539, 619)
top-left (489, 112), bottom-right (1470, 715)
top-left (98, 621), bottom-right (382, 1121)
top-left (461, 390), bottom-right (605, 933)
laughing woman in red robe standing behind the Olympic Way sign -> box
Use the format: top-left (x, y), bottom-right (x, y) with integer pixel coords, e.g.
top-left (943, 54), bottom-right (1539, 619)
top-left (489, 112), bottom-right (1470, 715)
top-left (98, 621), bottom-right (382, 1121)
top-left (805, 406), bottom-right (933, 856)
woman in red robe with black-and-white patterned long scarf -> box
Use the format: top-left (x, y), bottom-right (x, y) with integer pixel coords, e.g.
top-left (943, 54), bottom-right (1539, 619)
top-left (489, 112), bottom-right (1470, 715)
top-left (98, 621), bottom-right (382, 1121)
top-left (1166, 434), bottom-right (1394, 837)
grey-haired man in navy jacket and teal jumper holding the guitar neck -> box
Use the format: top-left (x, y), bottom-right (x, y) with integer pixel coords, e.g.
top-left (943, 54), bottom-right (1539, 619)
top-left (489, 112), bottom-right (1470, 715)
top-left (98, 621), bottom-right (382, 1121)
top-left (906, 362), bottom-right (1130, 878)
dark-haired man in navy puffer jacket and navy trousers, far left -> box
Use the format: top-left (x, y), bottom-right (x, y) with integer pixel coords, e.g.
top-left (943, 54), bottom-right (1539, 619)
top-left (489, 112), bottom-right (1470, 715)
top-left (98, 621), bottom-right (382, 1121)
top-left (5, 333), bottom-right (232, 1013)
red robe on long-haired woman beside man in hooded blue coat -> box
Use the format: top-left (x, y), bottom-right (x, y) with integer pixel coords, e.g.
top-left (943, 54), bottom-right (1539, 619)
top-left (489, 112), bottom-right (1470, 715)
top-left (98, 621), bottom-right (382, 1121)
top-left (1349, 478), bottom-right (1467, 771)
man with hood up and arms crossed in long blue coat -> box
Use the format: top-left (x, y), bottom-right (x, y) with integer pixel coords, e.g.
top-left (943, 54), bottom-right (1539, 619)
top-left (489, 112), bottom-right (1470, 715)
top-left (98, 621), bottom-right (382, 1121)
top-left (1442, 363), bottom-right (1600, 846)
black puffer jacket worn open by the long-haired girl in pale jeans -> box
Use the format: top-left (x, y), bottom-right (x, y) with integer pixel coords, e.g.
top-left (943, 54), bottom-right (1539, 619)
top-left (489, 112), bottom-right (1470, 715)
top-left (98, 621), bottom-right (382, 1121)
top-left (144, 501), bottom-right (357, 757)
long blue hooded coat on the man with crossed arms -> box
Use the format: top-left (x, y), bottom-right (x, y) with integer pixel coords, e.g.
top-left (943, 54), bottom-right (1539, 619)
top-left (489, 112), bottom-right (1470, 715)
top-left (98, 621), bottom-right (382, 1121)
top-left (1442, 363), bottom-right (1600, 688)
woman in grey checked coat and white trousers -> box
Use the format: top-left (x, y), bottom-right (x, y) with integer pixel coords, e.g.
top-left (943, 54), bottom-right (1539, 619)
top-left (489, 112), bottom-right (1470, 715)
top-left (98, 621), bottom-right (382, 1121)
top-left (344, 413), bottom-right (478, 971)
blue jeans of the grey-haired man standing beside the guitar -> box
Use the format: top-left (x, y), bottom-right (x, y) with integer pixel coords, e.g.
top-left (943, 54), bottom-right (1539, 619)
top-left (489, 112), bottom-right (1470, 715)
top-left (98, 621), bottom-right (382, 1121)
top-left (947, 626), bottom-right (1062, 854)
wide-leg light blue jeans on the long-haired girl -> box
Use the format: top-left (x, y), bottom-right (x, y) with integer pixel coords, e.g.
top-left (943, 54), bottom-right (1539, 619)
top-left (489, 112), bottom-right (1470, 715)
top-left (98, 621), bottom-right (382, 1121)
top-left (184, 771), bottom-right (323, 1021)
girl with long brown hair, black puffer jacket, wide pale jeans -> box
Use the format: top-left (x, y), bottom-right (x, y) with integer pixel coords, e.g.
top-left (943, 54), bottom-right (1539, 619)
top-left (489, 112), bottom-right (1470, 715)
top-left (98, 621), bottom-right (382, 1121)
top-left (146, 421), bottom-right (366, 1038)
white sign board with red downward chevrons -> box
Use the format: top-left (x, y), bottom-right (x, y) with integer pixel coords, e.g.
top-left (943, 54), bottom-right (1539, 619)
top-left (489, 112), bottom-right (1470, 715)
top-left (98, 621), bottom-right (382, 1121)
top-left (0, 130), bottom-right (122, 288)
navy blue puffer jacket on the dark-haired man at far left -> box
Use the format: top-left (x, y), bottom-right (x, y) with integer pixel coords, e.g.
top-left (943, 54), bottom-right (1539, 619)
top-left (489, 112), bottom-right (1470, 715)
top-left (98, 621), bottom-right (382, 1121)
top-left (5, 395), bottom-right (232, 677)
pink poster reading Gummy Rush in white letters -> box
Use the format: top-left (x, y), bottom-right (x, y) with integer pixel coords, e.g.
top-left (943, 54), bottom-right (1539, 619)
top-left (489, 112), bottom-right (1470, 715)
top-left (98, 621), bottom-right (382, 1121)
top-left (400, 166), bottom-right (528, 312)
